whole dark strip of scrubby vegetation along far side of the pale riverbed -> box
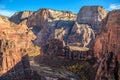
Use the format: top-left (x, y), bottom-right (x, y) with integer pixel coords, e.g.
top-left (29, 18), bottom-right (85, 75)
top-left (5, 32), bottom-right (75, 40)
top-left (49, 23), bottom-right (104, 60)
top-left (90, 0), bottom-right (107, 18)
top-left (35, 56), bottom-right (96, 80)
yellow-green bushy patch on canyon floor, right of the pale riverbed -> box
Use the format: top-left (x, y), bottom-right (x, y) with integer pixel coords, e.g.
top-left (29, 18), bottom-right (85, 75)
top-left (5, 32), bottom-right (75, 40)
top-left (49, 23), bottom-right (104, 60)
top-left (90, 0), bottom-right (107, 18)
top-left (62, 62), bottom-right (94, 80)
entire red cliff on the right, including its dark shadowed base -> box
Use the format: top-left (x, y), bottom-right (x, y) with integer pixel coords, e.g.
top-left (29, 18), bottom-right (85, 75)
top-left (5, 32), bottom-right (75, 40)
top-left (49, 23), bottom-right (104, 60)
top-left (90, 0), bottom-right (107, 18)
top-left (93, 10), bottom-right (120, 80)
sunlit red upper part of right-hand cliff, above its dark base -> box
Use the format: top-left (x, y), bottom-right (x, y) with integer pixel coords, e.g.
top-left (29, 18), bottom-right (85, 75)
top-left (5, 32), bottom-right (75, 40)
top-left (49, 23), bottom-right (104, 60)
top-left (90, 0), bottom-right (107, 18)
top-left (93, 10), bottom-right (120, 60)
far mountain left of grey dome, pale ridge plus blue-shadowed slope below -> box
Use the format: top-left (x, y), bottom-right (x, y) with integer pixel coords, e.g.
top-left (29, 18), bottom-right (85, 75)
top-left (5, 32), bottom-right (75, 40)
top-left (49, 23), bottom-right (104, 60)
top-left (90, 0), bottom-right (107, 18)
top-left (27, 9), bottom-right (76, 46)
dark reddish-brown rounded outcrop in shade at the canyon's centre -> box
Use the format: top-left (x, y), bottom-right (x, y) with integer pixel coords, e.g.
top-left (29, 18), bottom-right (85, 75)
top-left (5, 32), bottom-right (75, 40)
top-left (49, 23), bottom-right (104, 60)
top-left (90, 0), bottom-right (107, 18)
top-left (41, 39), bottom-right (65, 56)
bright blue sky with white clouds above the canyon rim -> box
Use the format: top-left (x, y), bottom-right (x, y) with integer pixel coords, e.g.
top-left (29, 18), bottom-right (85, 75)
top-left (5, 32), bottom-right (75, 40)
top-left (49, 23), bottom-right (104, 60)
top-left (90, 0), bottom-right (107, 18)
top-left (0, 0), bottom-right (120, 17)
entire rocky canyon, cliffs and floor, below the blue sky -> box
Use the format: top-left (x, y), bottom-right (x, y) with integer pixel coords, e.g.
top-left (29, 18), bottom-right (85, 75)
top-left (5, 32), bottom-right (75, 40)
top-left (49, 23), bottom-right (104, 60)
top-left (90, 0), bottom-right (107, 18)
top-left (0, 6), bottom-right (120, 80)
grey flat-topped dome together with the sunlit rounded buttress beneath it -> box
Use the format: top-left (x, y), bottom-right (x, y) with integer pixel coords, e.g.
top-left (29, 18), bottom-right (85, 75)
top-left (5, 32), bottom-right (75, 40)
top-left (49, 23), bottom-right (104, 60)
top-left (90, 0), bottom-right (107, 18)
top-left (68, 6), bottom-right (107, 48)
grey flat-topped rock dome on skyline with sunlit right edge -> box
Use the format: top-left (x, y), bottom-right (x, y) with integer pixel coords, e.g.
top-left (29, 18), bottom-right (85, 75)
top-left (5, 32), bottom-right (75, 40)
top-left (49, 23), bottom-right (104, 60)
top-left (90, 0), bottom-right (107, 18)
top-left (77, 6), bottom-right (107, 34)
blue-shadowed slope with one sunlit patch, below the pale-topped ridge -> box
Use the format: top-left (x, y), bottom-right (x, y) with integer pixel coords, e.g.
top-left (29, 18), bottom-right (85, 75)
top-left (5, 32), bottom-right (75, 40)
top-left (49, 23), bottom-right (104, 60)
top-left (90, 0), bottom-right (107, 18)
top-left (34, 20), bottom-right (74, 46)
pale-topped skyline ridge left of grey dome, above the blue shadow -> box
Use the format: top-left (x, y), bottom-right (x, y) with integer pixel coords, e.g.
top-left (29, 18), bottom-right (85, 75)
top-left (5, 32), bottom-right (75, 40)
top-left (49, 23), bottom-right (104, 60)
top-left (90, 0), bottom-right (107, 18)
top-left (28, 8), bottom-right (76, 28)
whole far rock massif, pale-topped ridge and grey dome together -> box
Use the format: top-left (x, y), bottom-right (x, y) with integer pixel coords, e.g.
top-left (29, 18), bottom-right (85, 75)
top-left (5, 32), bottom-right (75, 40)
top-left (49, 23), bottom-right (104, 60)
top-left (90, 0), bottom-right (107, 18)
top-left (27, 6), bottom-right (107, 48)
